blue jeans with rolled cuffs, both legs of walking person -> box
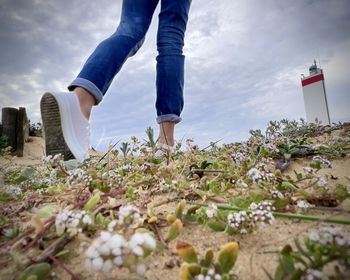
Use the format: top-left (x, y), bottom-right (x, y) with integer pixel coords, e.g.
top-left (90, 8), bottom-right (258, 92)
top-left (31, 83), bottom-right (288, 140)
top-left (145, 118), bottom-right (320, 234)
top-left (68, 0), bottom-right (191, 123)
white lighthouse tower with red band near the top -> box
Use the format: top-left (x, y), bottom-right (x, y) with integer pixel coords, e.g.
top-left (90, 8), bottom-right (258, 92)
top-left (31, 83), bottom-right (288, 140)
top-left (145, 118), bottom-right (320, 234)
top-left (301, 60), bottom-right (331, 125)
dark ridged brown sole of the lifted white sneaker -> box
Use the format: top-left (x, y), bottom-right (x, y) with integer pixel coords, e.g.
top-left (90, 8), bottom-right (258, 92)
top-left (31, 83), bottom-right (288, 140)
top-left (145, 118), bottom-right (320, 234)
top-left (40, 92), bottom-right (75, 160)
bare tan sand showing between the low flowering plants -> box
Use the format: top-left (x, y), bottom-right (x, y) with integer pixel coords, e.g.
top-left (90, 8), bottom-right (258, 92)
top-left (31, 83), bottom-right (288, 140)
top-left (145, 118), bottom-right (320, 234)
top-left (0, 137), bottom-right (350, 280)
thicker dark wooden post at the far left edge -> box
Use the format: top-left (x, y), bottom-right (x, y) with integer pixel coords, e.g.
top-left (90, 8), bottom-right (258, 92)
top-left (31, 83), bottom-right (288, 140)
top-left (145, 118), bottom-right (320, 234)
top-left (2, 107), bottom-right (18, 150)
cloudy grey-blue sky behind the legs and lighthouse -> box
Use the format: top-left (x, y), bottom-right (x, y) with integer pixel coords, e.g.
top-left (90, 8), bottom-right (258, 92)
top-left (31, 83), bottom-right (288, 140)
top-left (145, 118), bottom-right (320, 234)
top-left (0, 0), bottom-right (350, 150)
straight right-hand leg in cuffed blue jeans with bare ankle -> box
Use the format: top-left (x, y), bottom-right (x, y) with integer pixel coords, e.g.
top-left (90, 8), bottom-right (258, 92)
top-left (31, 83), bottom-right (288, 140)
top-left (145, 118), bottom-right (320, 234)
top-left (156, 0), bottom-right (191, 146)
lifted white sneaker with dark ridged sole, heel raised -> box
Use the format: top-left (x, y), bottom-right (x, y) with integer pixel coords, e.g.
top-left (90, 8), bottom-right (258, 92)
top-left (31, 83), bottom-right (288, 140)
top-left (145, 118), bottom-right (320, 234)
top-left (40, 92), bottom-right (90, 161)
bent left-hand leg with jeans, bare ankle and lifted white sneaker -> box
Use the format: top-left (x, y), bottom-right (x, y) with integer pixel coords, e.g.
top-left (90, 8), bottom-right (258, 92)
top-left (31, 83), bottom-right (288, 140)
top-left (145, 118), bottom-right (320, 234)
top-left (40, 0), bottom-right (159, 161)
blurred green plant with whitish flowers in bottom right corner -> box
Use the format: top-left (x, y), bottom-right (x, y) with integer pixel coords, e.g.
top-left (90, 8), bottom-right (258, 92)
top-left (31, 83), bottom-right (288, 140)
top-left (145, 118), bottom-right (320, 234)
top-left (266, 226), bottom-right (350, 280)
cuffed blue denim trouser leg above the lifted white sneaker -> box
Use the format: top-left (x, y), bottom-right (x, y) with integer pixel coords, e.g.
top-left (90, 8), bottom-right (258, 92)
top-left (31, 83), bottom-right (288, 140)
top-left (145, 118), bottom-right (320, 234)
top-left (68, 0), bottom-right (159, 104)
